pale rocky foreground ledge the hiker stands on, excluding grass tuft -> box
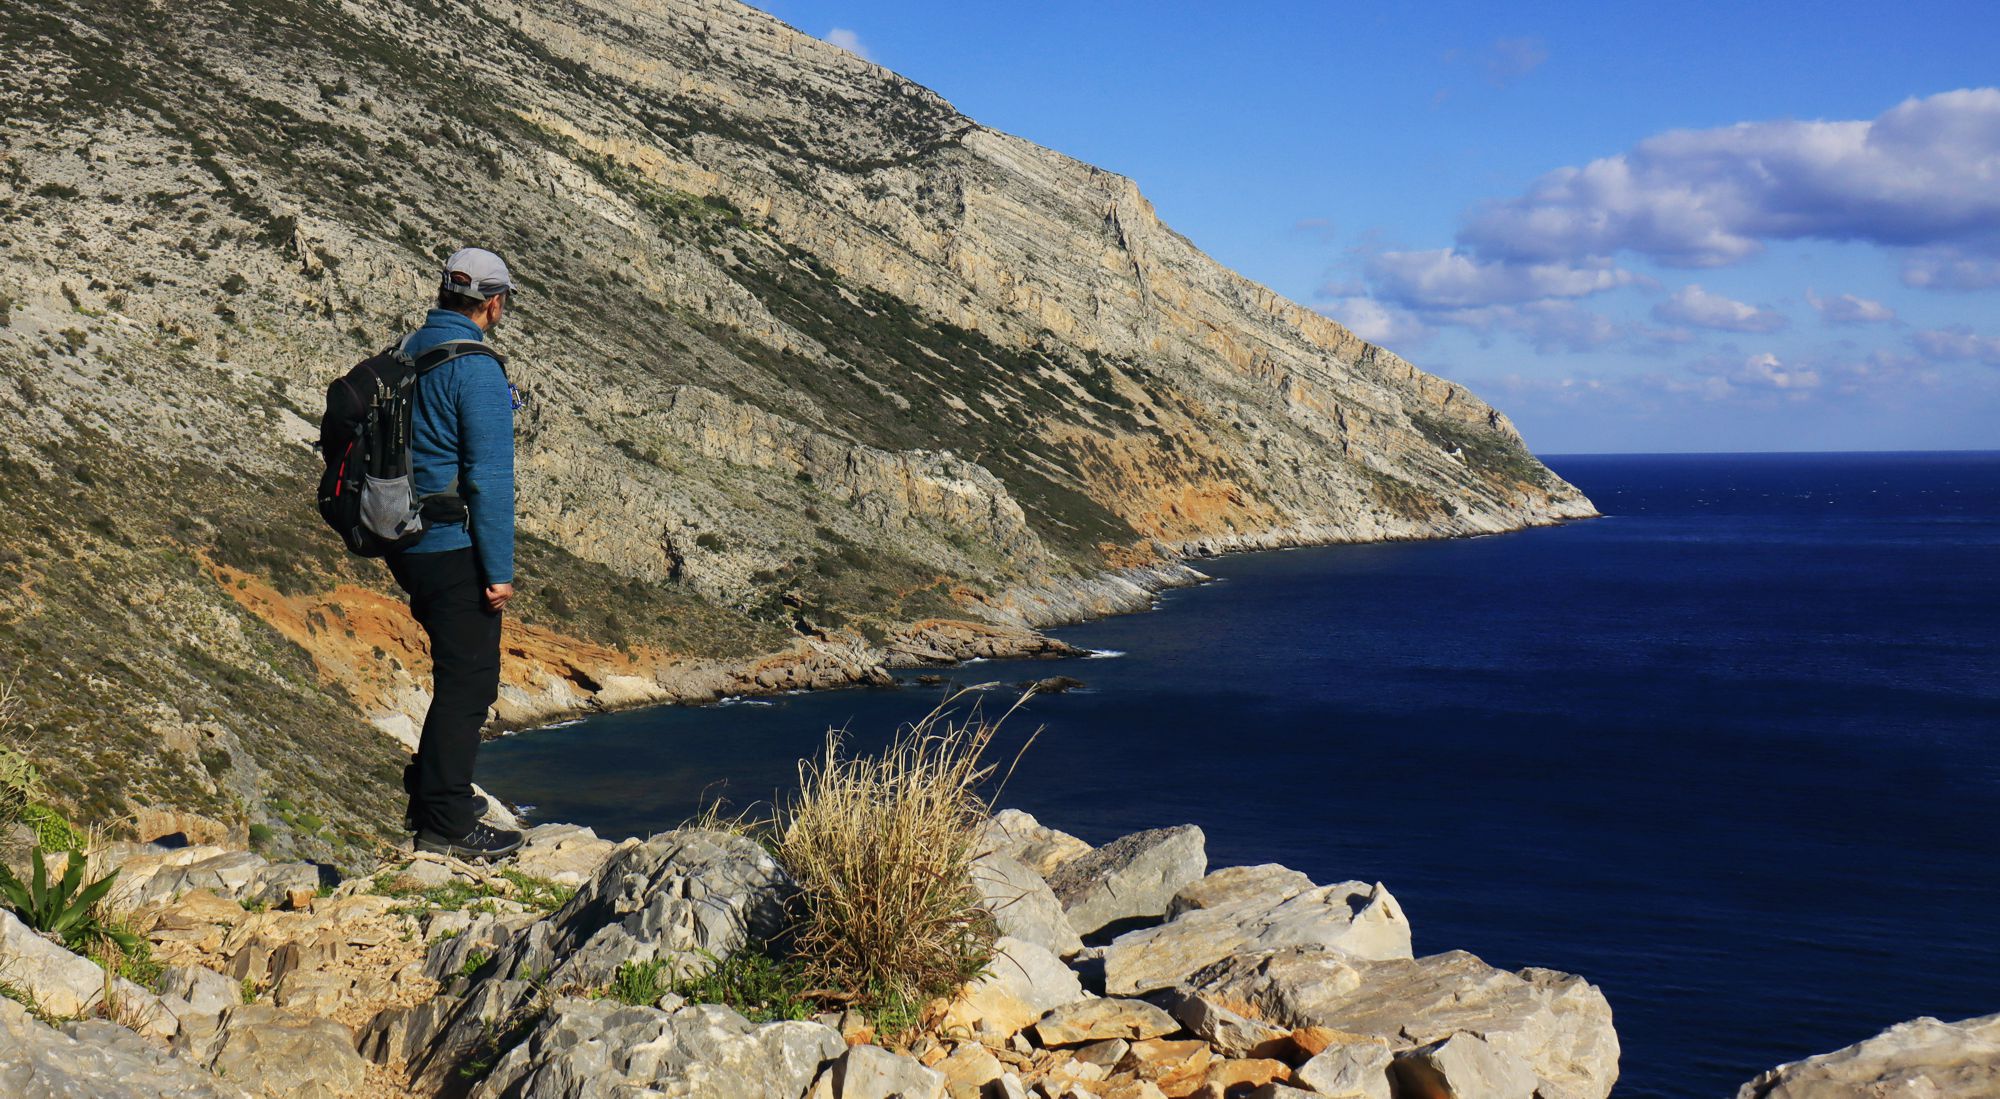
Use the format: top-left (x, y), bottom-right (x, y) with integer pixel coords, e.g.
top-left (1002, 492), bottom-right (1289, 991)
top-left (0, 811), bottom-right (1618, 1099)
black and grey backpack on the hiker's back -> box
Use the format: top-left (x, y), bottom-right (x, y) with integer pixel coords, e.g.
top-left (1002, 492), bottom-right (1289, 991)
top-left (320, 336), bottom-right (506, 557)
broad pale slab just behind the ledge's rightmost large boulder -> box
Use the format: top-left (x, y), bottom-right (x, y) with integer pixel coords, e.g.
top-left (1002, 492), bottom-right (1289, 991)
top-left (1104, 867), bottom-right (1410, 995)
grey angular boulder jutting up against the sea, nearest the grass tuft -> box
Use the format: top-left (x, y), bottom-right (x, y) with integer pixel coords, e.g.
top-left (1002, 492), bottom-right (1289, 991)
top-left (1048, 825), bottom-right (1208, 935)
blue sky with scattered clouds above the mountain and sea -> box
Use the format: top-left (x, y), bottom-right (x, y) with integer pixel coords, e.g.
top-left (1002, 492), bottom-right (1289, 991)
top-left (758, 0), bottom-right (2000, 454)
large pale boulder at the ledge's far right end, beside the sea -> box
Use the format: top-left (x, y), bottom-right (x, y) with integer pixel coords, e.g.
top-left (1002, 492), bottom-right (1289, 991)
top-left (1192, 945), bottom-right (1618, 1099)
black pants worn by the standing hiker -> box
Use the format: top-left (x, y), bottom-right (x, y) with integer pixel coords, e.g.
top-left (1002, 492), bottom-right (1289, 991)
top-left (386, 548), bottom-right (500, 839)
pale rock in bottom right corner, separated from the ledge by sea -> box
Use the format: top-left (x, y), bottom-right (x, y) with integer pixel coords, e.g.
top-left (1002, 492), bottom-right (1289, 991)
top-left (1736, 1015), bottom-right (2000, 1099)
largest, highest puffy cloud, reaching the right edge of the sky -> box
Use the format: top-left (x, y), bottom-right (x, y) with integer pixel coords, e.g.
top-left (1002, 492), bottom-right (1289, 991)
top-left (1460, 88), bottom-right (2000, 273)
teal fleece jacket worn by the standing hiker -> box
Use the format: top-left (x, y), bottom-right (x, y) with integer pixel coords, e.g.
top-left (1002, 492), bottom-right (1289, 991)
top-left (406, 310), bottom-right (514, 583)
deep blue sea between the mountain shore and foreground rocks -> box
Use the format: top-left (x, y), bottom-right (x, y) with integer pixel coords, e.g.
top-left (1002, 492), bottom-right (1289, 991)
top-left (480, 454), bottom-right (2000, 1097)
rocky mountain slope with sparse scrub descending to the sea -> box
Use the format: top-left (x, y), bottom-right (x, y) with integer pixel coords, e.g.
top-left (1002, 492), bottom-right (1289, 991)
top-left (0, 0), bottom-right (1592, 855)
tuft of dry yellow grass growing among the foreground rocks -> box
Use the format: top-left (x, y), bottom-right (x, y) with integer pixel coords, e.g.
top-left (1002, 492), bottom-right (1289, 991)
top-left (776, 695), bottom-right (1026, 1007)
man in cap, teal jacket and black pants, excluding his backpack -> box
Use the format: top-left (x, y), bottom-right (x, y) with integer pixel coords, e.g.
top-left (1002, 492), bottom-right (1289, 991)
top-left (388, 248), bottom-right (520, 859)
